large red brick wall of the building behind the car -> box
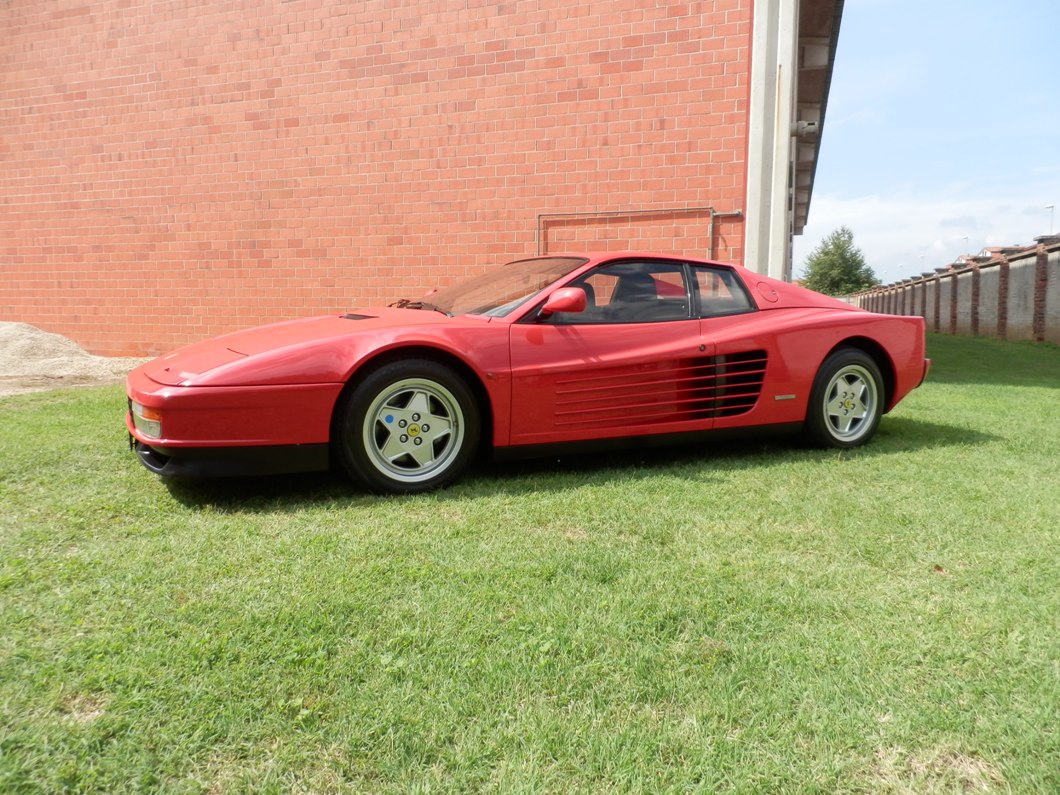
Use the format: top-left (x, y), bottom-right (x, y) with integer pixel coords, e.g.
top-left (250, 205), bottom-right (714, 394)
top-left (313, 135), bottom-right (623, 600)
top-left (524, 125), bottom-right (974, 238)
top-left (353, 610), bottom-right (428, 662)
top-left (0, 0), bottom-right (752, 354)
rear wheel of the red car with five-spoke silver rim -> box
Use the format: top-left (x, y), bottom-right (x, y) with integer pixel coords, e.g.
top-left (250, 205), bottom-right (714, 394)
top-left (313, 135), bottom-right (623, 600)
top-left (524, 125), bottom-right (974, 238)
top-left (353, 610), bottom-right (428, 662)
top-left (805, 348), bottom-right (886, 447)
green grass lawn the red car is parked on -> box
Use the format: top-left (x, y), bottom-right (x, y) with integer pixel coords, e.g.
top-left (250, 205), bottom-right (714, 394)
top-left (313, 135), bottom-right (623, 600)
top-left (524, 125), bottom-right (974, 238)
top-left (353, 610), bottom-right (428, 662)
top-left (0, 336), bottom-right (1060, 793)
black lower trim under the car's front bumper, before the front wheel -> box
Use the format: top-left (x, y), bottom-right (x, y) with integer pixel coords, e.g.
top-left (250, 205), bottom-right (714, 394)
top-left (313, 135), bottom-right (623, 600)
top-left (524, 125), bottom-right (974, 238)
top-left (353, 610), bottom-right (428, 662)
top-left (136, 442), bottom-right (330, 478)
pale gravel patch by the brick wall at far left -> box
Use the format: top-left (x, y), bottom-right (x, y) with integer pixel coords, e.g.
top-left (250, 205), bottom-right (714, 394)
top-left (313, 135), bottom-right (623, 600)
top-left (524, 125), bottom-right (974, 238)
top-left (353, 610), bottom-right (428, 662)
top-left (0, 322), bottom-right (149, 395)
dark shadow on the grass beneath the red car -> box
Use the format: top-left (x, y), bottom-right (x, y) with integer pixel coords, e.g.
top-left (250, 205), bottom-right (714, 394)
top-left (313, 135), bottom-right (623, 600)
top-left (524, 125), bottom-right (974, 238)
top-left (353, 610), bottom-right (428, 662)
top-left (156, 418), bottom-right (997, 513)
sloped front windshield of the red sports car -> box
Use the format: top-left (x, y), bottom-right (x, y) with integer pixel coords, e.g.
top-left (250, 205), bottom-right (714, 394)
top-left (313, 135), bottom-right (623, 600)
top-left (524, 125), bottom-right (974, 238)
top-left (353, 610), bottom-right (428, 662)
top-left (423, 257), bottom-right (586, 317)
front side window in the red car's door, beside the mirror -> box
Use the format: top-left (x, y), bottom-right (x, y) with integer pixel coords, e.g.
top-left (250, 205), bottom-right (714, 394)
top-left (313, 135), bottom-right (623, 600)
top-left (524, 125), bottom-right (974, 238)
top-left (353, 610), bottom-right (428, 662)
top-left (553, 262), bottom-right (691, 325)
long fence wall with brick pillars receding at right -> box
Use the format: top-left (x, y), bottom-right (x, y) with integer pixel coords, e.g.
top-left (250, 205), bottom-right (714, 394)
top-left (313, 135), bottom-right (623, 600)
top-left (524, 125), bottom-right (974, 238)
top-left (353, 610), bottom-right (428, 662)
top-left (851, 243), bottom-right (1060, 345)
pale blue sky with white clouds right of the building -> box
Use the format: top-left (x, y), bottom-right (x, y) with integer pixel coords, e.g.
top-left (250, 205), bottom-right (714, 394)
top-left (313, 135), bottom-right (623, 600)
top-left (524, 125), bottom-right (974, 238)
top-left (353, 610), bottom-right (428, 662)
top-left (794, 0), bottom-right (1060, 283)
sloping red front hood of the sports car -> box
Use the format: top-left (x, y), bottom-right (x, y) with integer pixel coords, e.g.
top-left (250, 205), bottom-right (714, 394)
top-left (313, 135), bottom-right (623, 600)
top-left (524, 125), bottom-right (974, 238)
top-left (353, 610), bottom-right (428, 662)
top-left (141, 307), bottom-right (452, 386)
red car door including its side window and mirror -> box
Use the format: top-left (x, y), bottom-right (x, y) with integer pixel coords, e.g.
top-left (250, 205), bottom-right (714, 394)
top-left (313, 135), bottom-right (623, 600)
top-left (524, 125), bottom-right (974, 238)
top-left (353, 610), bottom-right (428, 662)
top-left (510, 260), bottom-right (712, 445)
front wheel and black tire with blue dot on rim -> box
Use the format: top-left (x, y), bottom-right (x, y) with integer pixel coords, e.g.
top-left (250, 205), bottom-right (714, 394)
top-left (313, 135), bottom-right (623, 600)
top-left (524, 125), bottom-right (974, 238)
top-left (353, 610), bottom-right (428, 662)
top-left (334, 359), bottom-right (480, 494)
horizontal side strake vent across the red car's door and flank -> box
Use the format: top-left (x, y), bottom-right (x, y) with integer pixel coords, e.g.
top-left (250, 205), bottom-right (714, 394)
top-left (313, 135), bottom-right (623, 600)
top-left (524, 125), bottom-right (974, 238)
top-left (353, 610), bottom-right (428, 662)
top-left (555, 351), bottom-right (766, 428)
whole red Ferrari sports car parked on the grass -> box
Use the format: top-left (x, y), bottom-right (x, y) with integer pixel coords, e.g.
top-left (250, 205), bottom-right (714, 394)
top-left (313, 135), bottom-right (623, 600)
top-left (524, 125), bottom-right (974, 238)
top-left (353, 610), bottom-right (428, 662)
top-left (126, 253), bottom-right (930, 492)
